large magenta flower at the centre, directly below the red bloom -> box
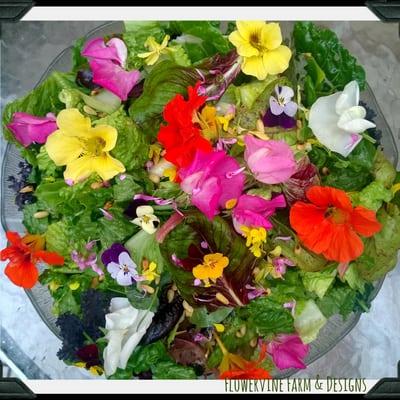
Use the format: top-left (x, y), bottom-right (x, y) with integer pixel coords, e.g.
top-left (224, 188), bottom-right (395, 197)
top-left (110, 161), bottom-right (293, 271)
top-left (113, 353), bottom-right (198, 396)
top-left (179, 150), bottom-right (245, 219)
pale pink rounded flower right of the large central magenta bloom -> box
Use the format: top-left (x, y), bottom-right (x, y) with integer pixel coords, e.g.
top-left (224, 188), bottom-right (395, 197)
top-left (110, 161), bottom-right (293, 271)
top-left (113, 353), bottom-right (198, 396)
top-left (244, 135), bottom-right (296, 184)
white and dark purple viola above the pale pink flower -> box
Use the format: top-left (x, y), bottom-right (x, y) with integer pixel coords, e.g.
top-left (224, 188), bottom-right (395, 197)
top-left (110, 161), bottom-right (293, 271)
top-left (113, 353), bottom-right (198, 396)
top-left (263, 85), bottom-right (297, 129)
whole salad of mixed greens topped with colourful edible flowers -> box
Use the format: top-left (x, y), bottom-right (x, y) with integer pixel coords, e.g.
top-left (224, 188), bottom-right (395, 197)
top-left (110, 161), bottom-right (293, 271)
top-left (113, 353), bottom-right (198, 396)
top-left (0, 21), bottom-right (400, 379)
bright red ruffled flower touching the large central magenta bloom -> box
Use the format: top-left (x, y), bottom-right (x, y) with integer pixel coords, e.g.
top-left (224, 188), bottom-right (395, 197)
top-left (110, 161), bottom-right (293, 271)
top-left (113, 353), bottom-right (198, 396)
top-left (157, 82), bottom-right (212, 168)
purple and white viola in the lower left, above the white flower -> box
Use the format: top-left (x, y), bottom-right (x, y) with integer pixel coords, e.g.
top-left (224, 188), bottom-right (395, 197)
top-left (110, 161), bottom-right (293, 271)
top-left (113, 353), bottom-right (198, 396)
top-left (101, 243), bottom-right (141, 286)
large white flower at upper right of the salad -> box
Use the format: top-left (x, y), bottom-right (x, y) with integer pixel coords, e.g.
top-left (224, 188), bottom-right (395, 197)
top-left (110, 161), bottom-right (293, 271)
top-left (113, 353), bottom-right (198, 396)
top-left (309, 81), bottom-right (376, 157)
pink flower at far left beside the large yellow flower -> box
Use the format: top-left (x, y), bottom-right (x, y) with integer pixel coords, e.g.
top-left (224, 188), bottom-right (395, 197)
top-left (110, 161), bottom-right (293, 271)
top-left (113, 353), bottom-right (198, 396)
top-left (7, 112), bottom-right (57, 147)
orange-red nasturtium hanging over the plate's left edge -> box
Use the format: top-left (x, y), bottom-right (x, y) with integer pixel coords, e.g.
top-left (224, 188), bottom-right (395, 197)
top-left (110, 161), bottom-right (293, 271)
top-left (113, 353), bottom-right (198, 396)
top-left (0, 231), bottom-right (64, 289)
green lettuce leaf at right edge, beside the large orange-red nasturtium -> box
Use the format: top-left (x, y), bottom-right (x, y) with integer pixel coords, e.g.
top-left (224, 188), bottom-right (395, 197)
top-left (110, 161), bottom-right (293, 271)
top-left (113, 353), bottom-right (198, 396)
top-left (354, 204), bottom-right (400, 282)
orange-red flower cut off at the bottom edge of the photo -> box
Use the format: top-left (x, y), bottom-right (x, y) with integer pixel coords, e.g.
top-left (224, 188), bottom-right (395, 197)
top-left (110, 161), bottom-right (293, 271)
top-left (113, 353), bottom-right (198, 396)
top-left (219, 343), bottom-right (272, 379)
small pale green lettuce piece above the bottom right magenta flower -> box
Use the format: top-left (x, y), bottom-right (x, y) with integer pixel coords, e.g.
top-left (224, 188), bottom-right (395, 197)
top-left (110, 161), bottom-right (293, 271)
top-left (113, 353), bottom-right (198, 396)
top-left (294, 300), bottom-right (327, 343)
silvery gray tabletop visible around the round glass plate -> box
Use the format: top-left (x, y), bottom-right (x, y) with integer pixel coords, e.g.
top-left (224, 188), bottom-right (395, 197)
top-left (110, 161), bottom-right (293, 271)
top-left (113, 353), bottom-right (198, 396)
top-left (0, 21), bottom-right (400, 379)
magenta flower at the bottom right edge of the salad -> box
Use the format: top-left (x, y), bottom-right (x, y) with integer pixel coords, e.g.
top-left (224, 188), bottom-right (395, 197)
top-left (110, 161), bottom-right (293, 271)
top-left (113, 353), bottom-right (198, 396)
top-left (267, 334), bottom-right (310, 369)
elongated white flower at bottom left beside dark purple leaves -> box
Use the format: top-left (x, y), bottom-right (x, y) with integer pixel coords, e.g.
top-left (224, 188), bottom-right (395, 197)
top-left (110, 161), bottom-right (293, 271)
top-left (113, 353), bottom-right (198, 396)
top-left (103, 297), bottom-right (154, 376)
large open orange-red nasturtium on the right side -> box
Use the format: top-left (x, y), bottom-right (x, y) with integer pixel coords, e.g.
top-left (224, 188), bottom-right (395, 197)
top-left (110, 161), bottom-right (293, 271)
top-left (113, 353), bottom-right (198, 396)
top-left (290, 186), bottom-right (381, 262)
